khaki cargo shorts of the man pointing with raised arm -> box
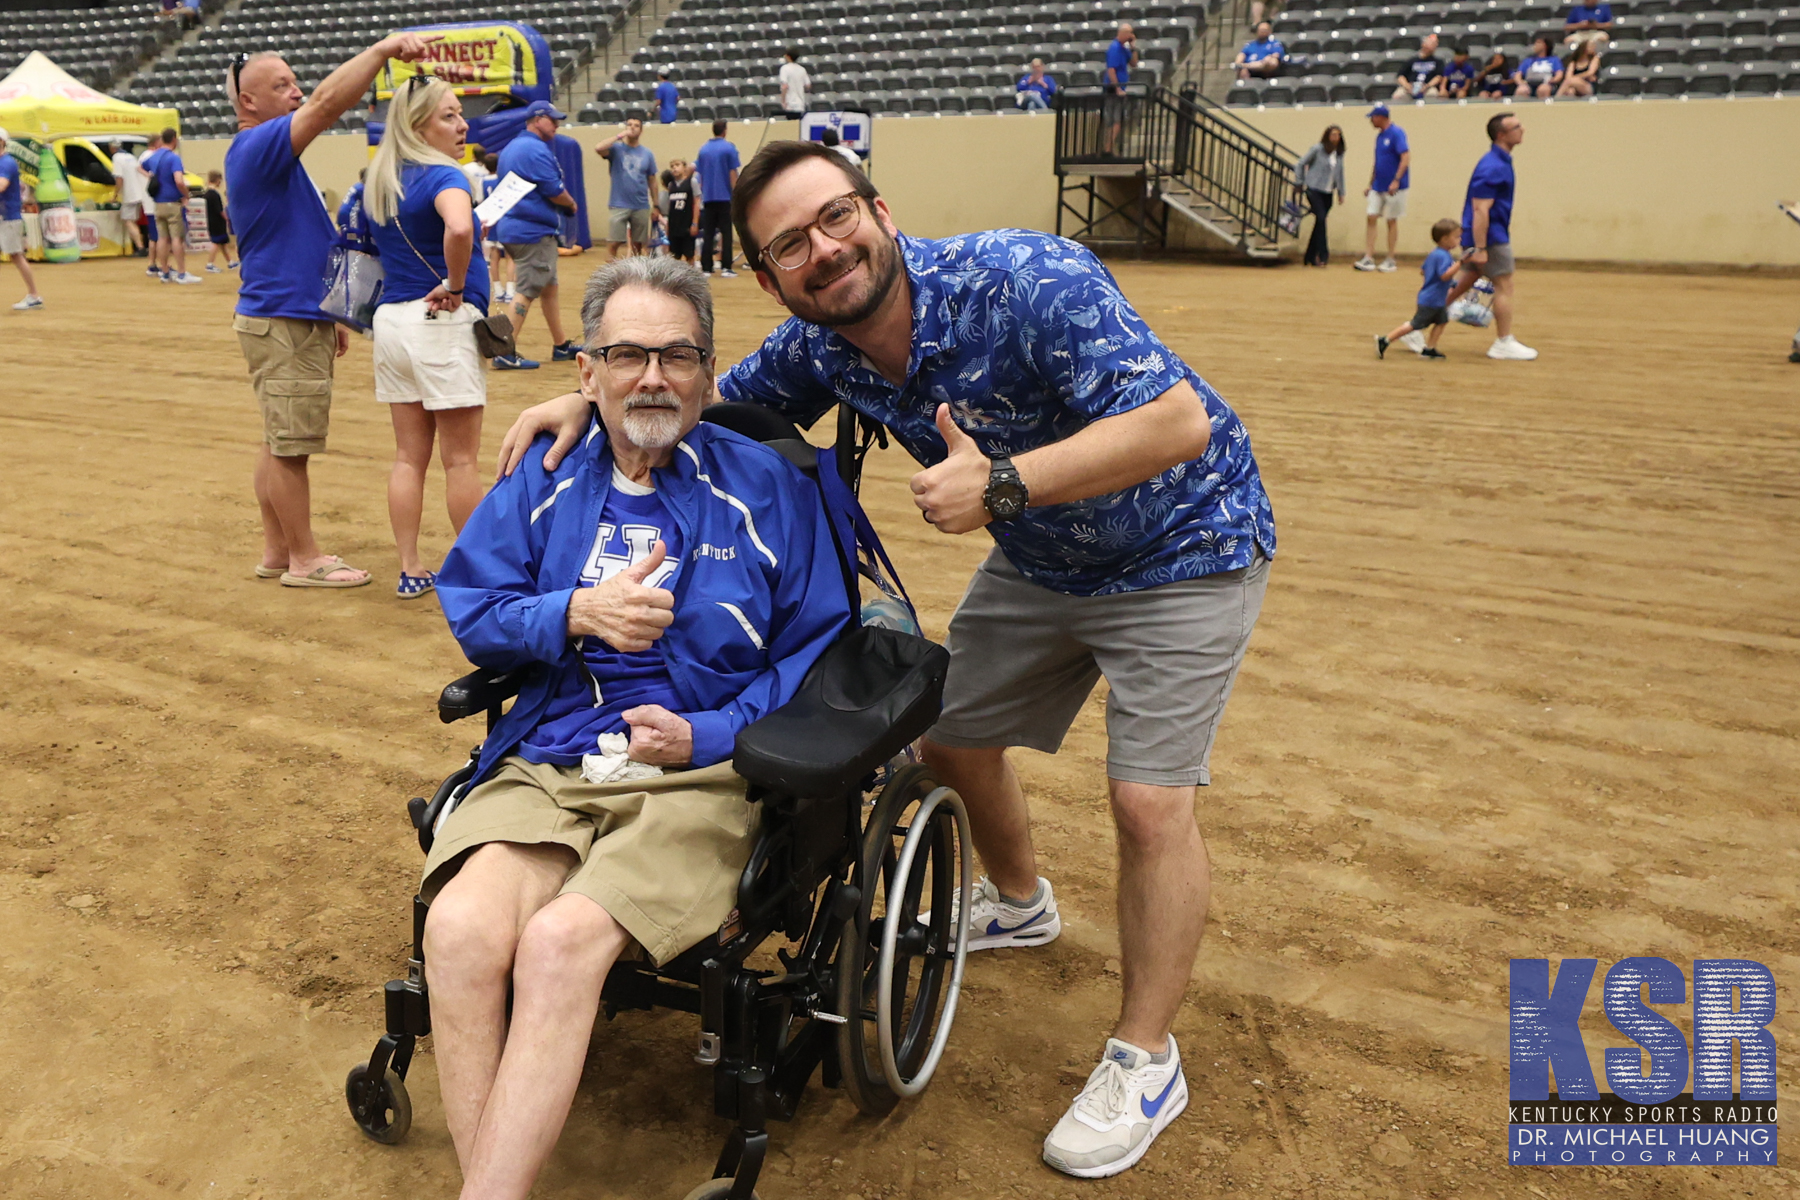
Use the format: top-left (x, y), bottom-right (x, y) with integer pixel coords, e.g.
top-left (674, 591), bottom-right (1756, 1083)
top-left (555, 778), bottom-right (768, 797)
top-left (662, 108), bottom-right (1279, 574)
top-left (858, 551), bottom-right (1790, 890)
top-left (230, 313), bottom-right (337, 459)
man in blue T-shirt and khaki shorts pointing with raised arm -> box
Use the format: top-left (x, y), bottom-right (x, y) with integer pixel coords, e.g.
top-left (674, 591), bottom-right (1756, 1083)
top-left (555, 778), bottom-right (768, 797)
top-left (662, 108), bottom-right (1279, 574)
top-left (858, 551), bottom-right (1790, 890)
top-left (225, 34), bottom-right (436, 588)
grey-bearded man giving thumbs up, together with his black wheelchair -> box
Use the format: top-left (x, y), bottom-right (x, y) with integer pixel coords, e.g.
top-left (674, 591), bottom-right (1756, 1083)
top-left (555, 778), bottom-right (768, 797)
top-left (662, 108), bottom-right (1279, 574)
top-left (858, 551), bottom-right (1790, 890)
top-left (347, 257), bottom-right (970, 1198)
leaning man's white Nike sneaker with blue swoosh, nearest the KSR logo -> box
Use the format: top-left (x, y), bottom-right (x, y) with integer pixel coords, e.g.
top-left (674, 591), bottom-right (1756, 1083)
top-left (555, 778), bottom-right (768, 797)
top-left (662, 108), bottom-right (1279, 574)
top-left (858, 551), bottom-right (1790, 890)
top-left (1044, 1038), bottom-right (1188, 1178)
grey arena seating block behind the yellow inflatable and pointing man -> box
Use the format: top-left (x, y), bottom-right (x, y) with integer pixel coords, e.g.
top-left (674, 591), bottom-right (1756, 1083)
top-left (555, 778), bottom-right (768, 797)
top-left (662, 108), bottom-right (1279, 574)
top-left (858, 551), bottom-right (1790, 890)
top-left (122, 0), bottom-right (635, 137)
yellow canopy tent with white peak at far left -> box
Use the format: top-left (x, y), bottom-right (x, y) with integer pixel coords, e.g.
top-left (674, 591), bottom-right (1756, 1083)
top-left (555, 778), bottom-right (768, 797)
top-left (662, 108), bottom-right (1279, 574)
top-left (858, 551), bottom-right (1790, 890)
top-left (0, 50), bottom-right (182, 257)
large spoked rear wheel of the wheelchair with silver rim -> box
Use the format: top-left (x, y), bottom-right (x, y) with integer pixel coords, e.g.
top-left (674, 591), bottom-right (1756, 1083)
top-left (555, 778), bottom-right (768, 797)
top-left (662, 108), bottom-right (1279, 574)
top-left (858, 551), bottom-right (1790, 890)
top-left (837, 765), bottom-right (974, 1115)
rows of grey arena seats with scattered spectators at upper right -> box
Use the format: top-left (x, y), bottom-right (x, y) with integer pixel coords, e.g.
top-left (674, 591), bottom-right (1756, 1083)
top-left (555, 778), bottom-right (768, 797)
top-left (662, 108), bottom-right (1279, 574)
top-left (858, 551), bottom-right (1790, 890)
top-left (1228, 0), bottom-right (1800, 106)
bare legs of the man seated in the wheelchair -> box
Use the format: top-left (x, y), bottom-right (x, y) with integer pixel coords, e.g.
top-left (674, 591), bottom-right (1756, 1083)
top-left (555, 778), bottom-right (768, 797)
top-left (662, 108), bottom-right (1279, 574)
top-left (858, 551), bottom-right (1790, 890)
top-left (425, 842), bottom-right (632, 1200)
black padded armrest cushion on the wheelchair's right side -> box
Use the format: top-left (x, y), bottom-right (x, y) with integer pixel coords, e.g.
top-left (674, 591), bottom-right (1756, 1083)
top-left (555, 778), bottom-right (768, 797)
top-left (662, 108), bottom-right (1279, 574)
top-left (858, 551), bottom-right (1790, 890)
top-left (731, 626), bottom-right (950, 799)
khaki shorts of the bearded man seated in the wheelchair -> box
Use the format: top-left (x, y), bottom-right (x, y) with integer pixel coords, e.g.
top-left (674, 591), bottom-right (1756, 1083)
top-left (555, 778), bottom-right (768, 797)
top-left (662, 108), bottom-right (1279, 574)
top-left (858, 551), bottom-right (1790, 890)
top-left (419, 756), bottom-right (761, 966)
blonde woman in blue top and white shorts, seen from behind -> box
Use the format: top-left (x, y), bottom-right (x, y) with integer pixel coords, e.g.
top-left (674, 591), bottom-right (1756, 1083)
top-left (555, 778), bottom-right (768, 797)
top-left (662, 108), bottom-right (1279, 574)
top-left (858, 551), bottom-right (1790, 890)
top-left (364, 76), bottom-right (488, 599)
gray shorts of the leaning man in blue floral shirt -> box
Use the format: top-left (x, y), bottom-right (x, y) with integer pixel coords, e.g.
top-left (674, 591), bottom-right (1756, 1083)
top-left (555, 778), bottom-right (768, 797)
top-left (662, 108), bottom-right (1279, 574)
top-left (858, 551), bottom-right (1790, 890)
top-left (927, 547), bottom-right (1269, 788)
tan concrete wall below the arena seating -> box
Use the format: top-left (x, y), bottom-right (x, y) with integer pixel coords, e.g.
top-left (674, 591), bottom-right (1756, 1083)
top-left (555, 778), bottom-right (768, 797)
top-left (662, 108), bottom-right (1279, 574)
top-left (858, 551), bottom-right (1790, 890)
top-left (184, 97), bottom-right (1800, 266)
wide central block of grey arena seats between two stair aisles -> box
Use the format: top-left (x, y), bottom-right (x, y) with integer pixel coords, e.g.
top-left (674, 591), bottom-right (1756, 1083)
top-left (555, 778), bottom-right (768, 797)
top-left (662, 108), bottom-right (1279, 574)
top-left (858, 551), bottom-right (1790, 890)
top-left (578, 0), bottom-right (1219, 124)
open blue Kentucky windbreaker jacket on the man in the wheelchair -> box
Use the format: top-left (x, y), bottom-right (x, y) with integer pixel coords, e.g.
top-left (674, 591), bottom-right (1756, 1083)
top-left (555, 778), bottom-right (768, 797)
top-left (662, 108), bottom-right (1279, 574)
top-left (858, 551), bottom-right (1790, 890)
top-left (437, 419), bottom-right (850, 781)
